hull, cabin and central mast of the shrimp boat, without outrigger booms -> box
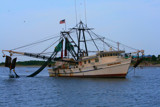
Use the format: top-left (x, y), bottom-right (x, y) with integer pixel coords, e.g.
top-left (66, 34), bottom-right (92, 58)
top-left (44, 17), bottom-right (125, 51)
top-left (48, 21), bottom-right (136, 77)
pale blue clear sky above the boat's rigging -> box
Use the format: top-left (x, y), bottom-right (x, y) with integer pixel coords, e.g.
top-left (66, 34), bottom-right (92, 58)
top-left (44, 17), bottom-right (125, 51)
top-left (0, 0), bottom-right (160, 62)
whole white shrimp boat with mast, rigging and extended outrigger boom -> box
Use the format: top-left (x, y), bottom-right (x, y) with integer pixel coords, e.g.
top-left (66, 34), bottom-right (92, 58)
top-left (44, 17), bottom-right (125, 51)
top-left (3, 21), bottom-right (144, 77)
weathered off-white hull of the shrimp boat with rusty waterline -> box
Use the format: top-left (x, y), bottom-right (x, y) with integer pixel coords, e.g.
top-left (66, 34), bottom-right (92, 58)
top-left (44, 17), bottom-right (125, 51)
top-left (48, 60), bottom-right (131, 77)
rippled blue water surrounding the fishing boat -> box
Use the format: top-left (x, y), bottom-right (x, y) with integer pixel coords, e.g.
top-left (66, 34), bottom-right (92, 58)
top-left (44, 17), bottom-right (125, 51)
top-left (0, 67), bottom-right (160, 107)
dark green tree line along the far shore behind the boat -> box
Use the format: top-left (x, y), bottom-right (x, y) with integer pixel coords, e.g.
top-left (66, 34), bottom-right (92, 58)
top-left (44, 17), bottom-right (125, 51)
top-left (0, 55), bottom-right (160, 67)
